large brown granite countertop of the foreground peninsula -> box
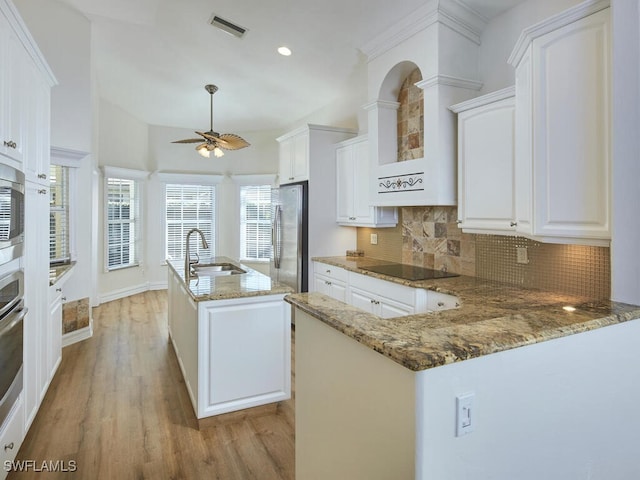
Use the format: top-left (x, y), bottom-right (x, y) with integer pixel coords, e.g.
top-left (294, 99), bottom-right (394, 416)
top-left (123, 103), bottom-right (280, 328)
top-left (285, 257), bottom-right (640, 371)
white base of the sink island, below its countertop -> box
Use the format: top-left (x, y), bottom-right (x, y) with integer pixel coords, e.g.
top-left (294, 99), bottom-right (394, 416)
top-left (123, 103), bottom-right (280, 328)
top-left (169, 272), bottom-right (291, 419)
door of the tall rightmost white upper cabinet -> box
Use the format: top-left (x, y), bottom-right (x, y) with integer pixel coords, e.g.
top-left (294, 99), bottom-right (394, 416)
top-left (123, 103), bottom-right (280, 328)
top-left (532, 9), bottom-right (611, 244)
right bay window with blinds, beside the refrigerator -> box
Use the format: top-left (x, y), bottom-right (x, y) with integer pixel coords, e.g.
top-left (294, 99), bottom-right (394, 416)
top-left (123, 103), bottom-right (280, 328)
top-left (240, 185), bottom-right (271, 260)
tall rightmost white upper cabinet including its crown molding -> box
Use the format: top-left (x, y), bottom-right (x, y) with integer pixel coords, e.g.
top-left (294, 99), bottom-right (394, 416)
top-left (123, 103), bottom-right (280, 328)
top-left (509, 1), bottom-right (611, 245)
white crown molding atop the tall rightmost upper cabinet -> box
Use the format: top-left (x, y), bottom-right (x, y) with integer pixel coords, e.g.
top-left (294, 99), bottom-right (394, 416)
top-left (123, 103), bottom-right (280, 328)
top-left (507, 0), bottom-right (611, 67)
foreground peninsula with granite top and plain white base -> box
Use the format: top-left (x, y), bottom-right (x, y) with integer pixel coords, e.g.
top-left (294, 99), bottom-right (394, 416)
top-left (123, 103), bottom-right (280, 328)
top-left (286, 257), bottom-right (640, 480)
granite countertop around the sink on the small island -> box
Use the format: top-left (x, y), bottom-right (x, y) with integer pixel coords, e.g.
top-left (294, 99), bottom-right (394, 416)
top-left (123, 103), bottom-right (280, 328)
top-left (167, 257), bottom-right (293, 302)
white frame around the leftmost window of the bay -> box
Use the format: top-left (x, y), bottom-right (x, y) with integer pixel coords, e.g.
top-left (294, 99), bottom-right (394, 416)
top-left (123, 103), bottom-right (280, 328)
top-left (102, 167), bottom-right (149, 273)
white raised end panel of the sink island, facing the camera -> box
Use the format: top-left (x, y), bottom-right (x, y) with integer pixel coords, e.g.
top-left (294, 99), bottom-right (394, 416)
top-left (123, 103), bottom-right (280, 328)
top-left (198, 295), bottom-right (291, 417)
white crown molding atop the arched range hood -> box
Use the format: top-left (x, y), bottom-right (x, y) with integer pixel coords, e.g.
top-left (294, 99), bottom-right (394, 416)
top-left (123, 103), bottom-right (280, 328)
top-left (360, 0), bottom-right (487, 61)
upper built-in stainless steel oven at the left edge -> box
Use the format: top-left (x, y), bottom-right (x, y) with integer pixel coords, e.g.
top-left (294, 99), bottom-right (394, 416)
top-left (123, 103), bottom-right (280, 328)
top-left (0, 164), bottom-right (24, 265)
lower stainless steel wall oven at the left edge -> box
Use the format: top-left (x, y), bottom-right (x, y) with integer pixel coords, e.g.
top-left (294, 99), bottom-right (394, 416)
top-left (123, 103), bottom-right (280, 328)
top-left (0, 270), bottom-right (27, 425)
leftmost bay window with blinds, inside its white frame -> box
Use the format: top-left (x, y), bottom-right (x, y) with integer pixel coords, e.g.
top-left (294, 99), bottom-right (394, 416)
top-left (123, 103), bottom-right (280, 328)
top-left (106, 177), bottom-right (141, 270)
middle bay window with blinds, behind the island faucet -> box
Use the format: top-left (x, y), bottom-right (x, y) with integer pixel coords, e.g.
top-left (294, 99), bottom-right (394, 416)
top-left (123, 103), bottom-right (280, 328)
top-left (165, 184), bottom-right (216, 260)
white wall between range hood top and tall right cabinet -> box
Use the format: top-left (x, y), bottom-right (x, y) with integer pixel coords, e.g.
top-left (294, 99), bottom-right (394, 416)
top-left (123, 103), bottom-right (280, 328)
top-left (479, 0), bottom-right (581, 94)
